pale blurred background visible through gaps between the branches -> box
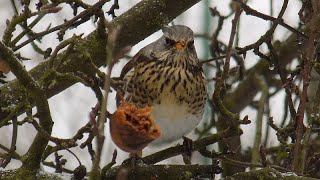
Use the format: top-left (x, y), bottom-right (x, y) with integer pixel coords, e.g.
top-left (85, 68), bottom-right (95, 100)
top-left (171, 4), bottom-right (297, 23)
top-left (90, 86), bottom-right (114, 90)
top-left (0, 0), bottom-right (301, 175)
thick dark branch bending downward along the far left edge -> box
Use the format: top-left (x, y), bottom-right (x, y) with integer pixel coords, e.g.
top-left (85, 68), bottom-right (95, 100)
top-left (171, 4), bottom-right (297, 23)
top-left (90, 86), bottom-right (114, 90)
top-left (0, 42), bottom-right (53, 170)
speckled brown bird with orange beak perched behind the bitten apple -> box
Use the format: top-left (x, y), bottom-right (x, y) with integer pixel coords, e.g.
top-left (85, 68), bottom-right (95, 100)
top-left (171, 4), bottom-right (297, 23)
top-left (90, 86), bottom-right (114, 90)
top-left (120, 25), bottom-right (207, 146)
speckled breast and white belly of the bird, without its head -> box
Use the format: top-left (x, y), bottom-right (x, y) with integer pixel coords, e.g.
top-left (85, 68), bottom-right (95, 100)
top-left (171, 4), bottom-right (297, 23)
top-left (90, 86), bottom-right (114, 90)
top-left (126, 58), bottom-right (206, 144)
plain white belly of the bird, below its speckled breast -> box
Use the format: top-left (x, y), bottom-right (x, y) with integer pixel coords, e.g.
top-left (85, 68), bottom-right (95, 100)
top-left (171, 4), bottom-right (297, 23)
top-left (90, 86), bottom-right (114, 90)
top-left (151, 94), bottom-right (201, 145)
